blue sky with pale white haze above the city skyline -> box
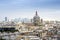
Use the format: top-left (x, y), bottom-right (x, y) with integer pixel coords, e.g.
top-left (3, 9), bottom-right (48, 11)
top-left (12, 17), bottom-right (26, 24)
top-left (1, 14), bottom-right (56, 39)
top-left (0, 0), bottom-right (60, 20)
